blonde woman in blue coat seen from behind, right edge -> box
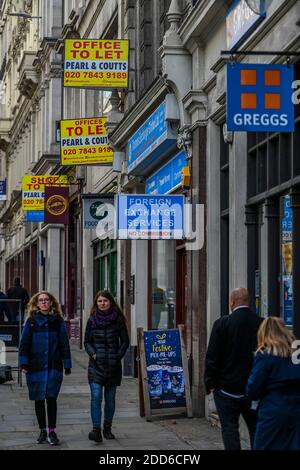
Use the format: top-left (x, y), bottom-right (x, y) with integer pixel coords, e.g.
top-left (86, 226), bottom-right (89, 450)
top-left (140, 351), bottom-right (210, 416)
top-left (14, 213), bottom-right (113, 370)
top-left (247, 317), bottom-right (300, 450)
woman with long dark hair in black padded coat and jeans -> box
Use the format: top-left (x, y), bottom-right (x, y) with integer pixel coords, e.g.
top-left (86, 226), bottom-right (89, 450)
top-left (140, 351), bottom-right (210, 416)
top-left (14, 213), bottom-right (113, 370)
top-left (84, 290), bottom-right (129, 442)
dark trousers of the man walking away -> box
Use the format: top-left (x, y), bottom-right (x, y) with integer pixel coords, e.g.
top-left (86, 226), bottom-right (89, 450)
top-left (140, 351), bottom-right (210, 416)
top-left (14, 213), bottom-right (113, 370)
top-left (214, 390), bottom-right (256, 450)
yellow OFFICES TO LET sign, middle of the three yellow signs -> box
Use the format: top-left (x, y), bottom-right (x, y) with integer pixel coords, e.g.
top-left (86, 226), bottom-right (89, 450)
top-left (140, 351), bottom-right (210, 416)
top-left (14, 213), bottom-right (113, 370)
top-left (60, 118), bottom-right (113, 165)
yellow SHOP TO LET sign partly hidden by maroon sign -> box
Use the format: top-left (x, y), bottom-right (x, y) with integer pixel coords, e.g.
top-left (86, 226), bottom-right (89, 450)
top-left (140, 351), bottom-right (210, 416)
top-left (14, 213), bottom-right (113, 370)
top-left (22, 175), bottom-right (68, 211)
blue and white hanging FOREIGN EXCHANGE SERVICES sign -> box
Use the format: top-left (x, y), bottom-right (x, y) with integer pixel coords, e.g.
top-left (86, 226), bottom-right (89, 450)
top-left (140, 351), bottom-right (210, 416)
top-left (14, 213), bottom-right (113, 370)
top-left (116, 194), bottom-right (184, 240)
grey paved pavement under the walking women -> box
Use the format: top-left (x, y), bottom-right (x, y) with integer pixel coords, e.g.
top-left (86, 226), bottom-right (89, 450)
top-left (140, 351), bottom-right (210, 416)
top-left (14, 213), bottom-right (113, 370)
top-left (0, 348), bottom-right (223, 451)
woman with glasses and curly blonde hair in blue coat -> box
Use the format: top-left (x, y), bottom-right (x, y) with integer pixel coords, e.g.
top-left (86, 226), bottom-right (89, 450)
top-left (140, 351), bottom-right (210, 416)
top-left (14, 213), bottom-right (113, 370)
top-left (19, 291), bottom-right (72, 445)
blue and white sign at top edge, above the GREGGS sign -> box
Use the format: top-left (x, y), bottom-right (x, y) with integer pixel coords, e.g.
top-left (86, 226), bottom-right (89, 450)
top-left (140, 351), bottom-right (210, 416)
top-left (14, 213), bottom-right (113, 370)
top-left (226, 0), bottom-right (266, 50)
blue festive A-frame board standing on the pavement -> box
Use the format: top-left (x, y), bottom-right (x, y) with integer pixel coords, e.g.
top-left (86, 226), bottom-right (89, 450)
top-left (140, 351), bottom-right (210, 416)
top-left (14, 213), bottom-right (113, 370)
top-left (137, 325), bottom-right (192, 421)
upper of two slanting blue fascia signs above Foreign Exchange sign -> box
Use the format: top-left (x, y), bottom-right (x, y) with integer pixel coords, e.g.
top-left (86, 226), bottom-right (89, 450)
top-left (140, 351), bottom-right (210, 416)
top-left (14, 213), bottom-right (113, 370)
top-left (128, 102), bottom-right (177, 175)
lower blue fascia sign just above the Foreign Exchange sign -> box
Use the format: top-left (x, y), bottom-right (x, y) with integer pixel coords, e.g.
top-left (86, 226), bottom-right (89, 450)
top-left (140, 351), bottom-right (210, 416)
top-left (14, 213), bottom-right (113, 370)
top-left (145, 150), bottom-right (186, 194)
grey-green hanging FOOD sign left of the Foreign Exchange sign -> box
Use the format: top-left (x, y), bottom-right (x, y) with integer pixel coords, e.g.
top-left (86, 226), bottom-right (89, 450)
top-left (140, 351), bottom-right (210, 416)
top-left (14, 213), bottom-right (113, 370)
top-left (83, 194), bottom-right (114, 233)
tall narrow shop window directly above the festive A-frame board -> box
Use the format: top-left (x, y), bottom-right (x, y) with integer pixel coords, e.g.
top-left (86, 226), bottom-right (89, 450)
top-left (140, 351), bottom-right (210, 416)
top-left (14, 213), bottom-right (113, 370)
top-left (151, 240), bottom-right (176, 329)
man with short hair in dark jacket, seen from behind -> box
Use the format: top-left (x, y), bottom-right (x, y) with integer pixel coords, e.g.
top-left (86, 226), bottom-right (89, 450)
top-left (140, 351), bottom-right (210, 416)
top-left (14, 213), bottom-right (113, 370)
top-left (204, 287), bottom-right (262, 450)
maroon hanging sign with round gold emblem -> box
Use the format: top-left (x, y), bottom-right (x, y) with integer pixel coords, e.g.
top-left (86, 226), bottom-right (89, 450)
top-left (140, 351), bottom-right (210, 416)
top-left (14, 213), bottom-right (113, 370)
top-left (45, 186), bottom-right (69, 225)
